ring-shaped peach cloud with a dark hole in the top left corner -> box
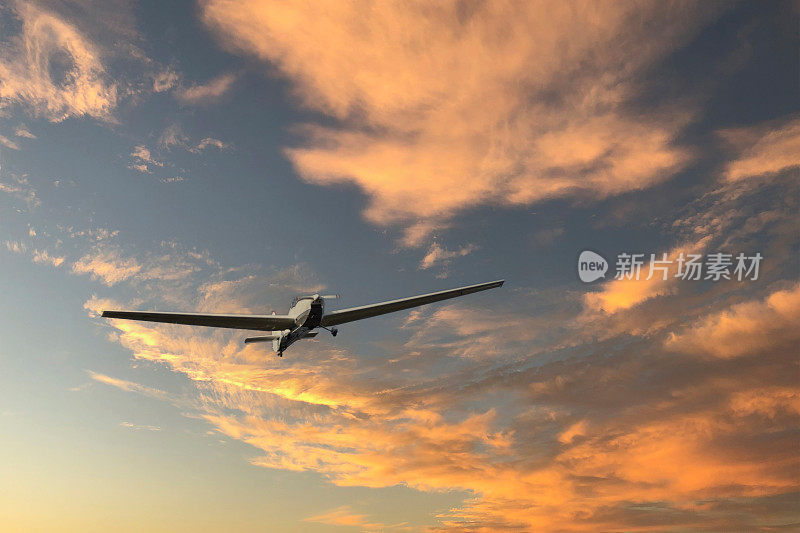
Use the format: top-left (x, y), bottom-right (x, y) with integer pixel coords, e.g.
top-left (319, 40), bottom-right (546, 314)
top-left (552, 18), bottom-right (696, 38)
top-left (0, 2), bottom-right (117, 122)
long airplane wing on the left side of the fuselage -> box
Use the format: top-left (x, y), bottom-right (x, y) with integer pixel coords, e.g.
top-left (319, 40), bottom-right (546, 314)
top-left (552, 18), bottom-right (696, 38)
top-left (102, 311), bottom-right (297, 331)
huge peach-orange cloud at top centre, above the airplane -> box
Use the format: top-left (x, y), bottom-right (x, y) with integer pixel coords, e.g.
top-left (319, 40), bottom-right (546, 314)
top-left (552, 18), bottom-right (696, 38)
top-left (203, 0), bottom-right (713, 245)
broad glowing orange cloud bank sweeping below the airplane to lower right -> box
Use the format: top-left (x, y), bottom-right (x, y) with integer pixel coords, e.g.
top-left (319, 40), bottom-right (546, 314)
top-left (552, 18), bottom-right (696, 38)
top-left (95, 294), bottom-right (800, 531)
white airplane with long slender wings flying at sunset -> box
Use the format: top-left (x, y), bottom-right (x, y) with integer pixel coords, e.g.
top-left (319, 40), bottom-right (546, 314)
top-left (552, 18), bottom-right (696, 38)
top-left (101, 279), bottom-right (505, 357)
